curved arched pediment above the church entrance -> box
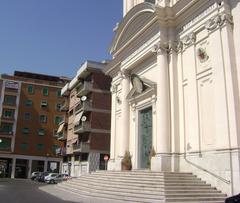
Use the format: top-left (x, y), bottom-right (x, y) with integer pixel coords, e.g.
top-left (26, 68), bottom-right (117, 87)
top-left (110, 3), bottom-right (155, 54)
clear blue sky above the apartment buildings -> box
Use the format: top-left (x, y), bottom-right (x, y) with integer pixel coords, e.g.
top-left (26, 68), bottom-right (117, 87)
top-left (0, 0), bottom-right (122, 77)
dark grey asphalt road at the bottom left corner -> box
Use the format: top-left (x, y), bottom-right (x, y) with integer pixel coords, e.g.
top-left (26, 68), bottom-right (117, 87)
top-left (0, 179), bottom-right (81, 203)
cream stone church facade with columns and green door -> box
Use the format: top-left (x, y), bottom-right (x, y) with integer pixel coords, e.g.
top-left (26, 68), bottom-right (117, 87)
top-left (104, 0), bottom-right (240, 195)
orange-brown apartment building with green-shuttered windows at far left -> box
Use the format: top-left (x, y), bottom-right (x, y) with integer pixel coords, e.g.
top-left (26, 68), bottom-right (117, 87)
top-left (0, 71), bottom-right (68, 178)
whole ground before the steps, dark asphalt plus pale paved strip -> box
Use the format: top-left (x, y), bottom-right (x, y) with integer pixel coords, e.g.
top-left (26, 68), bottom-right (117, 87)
top-left (0, 179), bottom-right (126, 203)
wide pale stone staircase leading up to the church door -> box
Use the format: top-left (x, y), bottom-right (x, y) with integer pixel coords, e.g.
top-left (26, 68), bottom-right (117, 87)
top-left (57, 171), bottom-right (226, 203)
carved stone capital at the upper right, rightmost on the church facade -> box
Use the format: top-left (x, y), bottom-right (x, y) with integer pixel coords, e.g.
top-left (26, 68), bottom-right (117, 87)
top-left (205, 13), bottom-right (233, 31)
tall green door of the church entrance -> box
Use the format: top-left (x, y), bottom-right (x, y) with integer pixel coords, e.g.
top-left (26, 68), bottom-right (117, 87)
top-left (140, 107), bottom-right (152, 168)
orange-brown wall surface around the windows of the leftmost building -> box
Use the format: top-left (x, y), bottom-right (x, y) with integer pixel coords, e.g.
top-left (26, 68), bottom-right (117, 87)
top-left (14, 83), bottom-right (64, 156)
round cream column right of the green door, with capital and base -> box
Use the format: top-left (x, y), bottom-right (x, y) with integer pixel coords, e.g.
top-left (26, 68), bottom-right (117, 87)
top-left (151, 42), bottom-right (171, 171)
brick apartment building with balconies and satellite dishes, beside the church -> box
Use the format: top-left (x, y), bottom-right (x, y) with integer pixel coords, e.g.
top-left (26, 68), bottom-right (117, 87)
top-left (58, 61), bottom-right (111, 177)
